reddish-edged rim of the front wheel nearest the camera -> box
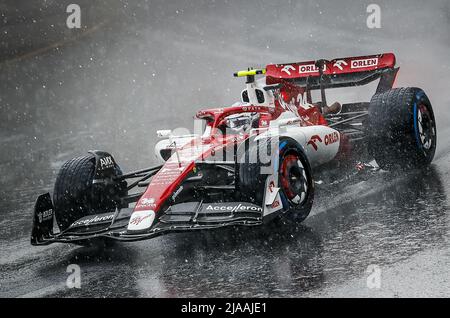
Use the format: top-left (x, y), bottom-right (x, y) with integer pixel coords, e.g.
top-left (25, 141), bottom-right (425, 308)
top-left (280, 154), bottom-right (308, 205)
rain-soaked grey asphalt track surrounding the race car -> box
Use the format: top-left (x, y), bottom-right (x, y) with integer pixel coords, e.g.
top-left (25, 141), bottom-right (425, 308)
top-left (0, 1), bottom-right (450, 297)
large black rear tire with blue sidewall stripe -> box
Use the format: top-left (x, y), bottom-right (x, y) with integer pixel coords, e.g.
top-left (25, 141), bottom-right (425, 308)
top-left (367, 87), bottom-right (437, 170)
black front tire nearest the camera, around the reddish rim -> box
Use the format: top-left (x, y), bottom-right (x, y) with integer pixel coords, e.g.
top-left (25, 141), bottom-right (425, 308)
top-left (239, 138), bottom-right (314, 222)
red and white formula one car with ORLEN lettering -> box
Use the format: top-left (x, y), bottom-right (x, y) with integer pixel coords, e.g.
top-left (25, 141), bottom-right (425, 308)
top-left (31, 53), bottom-right (437, 245)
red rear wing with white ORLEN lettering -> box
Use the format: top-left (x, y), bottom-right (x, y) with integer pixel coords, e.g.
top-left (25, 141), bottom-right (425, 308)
top-left (266, 53), bottom-right (399, 93)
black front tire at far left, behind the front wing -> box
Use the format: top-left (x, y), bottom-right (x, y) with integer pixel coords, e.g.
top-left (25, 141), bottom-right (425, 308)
top-left (53, 155), bottom-right (121, 231)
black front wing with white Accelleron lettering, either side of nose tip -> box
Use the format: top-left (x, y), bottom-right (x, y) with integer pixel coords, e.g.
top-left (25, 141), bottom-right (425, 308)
top-left (31, 193), bottom-right (263, 245)
